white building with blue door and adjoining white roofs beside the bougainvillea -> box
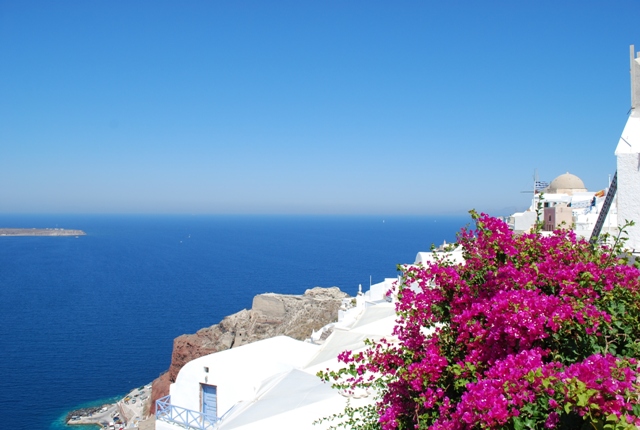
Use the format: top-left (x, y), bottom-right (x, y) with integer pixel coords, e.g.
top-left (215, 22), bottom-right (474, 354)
top-left (156, 278), bottom-right (395, 430)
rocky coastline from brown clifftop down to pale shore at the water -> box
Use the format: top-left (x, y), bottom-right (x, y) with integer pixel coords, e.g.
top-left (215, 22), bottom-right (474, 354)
top-left (66, 287), bottom-right (349, 430)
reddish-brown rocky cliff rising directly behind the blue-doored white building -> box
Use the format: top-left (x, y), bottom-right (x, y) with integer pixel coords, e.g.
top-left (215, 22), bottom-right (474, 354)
top-left (151, 287), bottom-right (348, 411)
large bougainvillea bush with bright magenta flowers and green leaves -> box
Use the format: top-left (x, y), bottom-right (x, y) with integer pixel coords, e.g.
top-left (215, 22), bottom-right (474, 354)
top-left (320, 212), bottom-right (640, 430)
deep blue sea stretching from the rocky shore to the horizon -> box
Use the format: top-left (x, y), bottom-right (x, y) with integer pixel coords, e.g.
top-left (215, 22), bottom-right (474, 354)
top-left (0, 215), bottom-right (470, 430)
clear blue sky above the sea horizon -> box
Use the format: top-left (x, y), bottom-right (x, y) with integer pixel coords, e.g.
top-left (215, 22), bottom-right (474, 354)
top-left (0, 0), bottom-right (640, 215)
